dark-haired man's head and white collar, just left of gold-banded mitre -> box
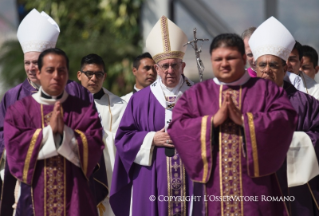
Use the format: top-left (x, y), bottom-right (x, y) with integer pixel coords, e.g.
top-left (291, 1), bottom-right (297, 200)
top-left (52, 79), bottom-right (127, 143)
top-left (121, 52), bottom-right (156, 102)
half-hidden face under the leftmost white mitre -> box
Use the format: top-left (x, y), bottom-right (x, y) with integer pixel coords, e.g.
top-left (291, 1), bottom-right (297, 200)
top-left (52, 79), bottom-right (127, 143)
top-left (24, 52), bottom-right (40, 85)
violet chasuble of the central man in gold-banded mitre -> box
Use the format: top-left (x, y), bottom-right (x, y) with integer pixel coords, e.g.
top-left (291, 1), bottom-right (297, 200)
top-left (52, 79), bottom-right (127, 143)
top-left (110, 85), bottom-right (192, 216)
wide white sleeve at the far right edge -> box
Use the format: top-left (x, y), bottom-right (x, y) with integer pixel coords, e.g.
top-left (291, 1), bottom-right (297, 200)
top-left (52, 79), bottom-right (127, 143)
top-left (287, 131), bottom-right (319, 187)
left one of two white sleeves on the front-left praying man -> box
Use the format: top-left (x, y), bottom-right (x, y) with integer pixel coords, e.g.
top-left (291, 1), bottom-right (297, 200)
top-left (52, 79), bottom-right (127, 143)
top-left (38, 125), bottom-right (58, 160)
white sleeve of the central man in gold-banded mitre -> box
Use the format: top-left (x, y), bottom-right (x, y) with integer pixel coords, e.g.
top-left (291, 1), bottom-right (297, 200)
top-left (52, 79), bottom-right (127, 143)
top-left (134, 131), bottom-right (156, 166)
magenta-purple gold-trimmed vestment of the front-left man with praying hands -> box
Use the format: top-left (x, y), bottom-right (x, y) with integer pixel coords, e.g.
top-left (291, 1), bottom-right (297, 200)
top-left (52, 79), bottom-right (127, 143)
top-left (4, 95), bottom-right (104, 216)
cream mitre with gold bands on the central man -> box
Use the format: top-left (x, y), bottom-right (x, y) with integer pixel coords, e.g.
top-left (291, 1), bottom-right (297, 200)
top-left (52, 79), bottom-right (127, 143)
top-left (146, 16), bottom-right (188, 63)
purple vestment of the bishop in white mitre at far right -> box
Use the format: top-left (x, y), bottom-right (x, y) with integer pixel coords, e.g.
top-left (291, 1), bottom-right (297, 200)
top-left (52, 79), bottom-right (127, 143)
top-left (277, 81), bottom-right (319, 216)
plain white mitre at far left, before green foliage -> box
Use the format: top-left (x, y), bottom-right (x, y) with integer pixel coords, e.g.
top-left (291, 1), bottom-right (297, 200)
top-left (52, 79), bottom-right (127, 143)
top-left (17, 9), bottom-right (60, 53)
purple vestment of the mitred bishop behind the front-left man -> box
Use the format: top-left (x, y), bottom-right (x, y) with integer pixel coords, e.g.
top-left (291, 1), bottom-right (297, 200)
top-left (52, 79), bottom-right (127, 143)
top-left (0, 79), bottom-right (97, 215)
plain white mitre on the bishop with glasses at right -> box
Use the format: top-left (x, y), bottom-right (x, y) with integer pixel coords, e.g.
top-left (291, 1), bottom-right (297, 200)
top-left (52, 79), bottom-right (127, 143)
top-left (248, 17), bottom-right (296, 61)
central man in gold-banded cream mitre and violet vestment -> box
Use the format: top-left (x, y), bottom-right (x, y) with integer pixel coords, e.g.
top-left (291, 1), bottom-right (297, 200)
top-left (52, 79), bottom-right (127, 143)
top-left (110, 16), bottom-right (192, 216)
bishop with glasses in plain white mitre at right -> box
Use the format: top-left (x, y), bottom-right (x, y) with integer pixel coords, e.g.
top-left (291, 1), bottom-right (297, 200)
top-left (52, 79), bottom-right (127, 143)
top-left (249, 17), bottom-right (319, 216)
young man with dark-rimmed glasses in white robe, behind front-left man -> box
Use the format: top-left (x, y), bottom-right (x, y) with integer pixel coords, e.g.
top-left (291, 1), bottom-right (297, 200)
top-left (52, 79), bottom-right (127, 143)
top-left (77, 54), bottom-right (126, 216)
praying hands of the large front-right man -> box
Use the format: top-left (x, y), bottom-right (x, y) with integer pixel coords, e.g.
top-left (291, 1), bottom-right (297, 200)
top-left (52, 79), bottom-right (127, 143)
top-left (213, 92), bottom-right (243, 127)
